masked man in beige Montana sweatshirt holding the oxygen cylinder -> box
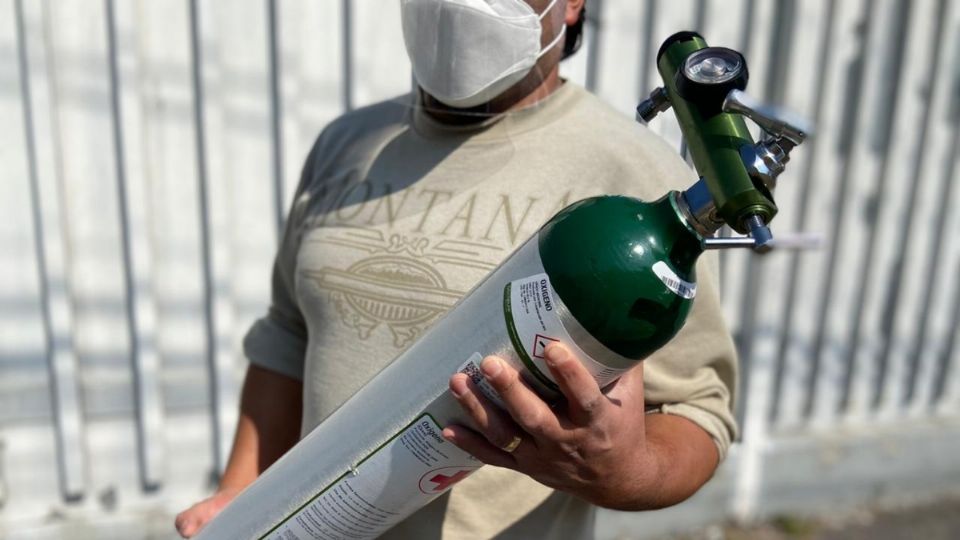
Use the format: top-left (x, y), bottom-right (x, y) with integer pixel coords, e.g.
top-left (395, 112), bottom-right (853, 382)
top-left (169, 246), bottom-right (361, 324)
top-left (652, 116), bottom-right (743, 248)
top-left (177, 0), bottom-right (736, 538)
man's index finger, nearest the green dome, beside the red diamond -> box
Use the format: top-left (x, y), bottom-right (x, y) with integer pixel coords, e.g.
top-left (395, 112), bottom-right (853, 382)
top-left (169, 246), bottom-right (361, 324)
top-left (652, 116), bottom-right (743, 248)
top-left (544, 343), bottom-right (607, 425)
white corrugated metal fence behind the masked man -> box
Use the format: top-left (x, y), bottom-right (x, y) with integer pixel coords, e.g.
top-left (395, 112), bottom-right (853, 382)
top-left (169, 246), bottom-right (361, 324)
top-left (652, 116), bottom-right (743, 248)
top-left (0, 0), bottom-right (960, 538)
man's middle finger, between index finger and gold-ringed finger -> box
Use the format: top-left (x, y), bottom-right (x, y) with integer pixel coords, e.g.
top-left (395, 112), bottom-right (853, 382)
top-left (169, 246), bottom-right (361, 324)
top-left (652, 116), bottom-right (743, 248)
top-left (480, 356), bottom-right (560, 438)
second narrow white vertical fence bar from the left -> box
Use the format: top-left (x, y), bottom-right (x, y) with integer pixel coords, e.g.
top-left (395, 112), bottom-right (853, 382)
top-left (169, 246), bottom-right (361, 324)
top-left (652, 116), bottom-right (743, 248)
top-left (106, 0), bottom-right (164, 491)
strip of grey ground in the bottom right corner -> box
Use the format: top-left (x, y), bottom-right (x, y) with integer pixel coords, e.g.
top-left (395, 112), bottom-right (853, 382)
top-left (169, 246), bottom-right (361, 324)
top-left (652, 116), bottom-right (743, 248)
top-left (659, 498), bottom-right (960, 540)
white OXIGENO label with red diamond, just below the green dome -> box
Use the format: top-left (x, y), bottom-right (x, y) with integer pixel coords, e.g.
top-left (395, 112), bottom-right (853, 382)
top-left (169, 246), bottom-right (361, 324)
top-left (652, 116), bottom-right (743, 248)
top-left (504, 274), bottom-right (629, 388)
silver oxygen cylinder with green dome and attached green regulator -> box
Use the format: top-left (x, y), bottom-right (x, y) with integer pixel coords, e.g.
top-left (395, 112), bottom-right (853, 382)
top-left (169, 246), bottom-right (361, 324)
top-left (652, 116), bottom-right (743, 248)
top-left (200, 32), bottom-right (805, 540)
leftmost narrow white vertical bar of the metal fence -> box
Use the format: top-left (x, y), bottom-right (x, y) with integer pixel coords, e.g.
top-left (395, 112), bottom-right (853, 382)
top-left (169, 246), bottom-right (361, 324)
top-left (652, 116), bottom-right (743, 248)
top-left (15, 0), bottom-right (87, 501)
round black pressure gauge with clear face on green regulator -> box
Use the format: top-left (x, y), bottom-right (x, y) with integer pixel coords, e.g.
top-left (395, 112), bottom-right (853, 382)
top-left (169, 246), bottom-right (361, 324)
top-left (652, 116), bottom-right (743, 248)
top-left (676, 47), bottom-right (749, 116)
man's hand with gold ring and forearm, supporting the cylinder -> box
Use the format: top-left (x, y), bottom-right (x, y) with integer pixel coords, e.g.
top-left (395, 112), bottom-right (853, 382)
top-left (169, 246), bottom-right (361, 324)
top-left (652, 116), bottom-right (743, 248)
top-left (443, 344), bottom-right (717, 510)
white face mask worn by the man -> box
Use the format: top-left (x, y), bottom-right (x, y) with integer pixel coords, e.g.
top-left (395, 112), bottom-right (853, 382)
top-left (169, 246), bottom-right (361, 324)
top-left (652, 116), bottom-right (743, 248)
top-left (400, 0), bottom-right (566, 108)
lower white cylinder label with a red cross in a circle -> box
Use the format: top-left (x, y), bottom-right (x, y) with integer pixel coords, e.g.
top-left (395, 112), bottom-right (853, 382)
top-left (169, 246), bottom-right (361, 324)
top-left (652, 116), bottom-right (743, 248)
top-left (266, 414), bottom-right (483, 540)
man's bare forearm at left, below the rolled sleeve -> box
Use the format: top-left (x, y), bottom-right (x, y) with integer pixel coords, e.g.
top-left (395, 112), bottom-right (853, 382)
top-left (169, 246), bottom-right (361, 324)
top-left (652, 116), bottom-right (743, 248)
top-left (218, 365), bottom-right (303, 491)
